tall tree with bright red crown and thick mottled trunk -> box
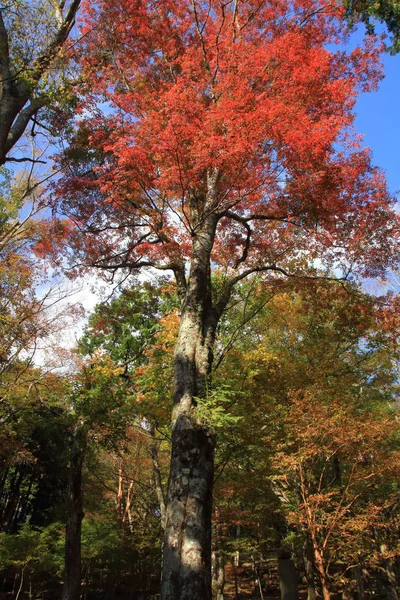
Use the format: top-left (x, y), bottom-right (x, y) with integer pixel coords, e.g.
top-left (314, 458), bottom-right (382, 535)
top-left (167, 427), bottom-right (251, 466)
top-left (52, 0), bottom-right (397, 600)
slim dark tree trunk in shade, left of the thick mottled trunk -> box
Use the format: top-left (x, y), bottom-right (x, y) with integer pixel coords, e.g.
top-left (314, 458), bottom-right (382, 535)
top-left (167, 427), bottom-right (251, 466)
top-left (61, 426), bottom-right (86, 600)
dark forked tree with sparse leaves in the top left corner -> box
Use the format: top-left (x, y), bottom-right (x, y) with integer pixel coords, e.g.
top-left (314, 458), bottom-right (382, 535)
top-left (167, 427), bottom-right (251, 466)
top-left (0, 0), bottom-right (80, 165)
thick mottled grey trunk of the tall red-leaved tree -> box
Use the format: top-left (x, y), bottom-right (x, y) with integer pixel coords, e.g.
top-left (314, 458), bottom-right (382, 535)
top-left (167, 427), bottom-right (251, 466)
top-left (161, 209), bottom-right (218, 600)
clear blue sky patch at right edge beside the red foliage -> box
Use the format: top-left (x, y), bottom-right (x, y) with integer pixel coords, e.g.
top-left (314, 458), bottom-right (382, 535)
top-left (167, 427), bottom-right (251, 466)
top-left (355, 47), bottom-right (400, 193)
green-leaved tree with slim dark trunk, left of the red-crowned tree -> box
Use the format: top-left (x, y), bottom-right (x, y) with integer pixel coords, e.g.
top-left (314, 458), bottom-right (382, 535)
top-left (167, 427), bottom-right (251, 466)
top-left (62, 284), bottom-right (169, 600)
